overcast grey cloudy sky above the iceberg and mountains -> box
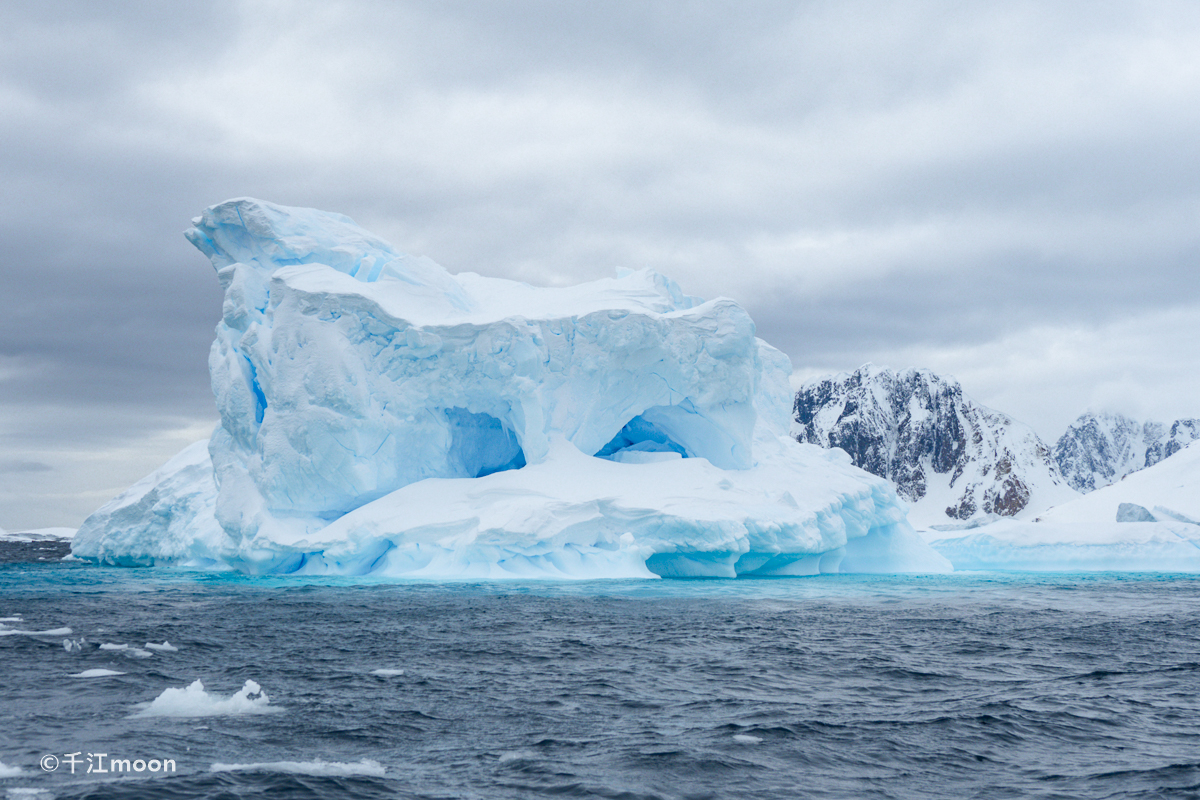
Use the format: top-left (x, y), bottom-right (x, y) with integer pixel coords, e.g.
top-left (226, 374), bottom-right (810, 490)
top-left (0, 0), bottom-right (1200, 530)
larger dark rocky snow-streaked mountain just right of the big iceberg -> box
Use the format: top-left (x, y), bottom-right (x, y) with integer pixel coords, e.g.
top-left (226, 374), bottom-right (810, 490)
top-left (792, 363), bottom-right (1078, 528)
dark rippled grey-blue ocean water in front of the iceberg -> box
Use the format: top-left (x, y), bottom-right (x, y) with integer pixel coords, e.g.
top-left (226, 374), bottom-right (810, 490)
top-left (0, 563), bottom-right (1200, 800)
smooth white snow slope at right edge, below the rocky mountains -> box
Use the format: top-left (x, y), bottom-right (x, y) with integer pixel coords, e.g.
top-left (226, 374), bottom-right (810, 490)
top-left (932, 443), bottom-right (1200, 572)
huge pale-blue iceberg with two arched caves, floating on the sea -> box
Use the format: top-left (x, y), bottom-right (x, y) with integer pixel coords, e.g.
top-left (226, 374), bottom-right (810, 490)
top-left (72, 198), bottom-right (950, 579)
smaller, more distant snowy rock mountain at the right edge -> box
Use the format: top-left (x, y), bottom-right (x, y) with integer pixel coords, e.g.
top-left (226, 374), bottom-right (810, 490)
top-left (1054, 411), bottom-right (1200, 492)
